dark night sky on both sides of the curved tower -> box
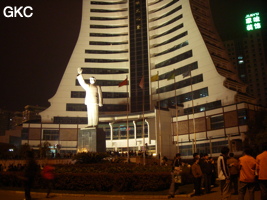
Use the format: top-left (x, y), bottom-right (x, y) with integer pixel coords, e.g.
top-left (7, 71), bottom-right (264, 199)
top-left (0, 0), bottom-right (266, 111)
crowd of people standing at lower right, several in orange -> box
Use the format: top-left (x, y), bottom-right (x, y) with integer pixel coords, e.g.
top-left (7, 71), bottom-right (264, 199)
top-left (168, 144), bottom-right (267, 200)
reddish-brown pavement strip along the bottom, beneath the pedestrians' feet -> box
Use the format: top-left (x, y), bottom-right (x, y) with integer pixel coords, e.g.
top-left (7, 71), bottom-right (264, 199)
top-left (0, 187), bottom-right (260, 200)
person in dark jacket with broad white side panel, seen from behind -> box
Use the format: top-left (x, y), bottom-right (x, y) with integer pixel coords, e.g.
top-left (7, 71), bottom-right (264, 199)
top-left (217, 147), bottom-right (231, 200)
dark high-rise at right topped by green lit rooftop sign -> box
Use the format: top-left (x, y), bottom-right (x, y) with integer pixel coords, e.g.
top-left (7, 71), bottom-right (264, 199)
top-left (224, 12), bottom-right (267, 107)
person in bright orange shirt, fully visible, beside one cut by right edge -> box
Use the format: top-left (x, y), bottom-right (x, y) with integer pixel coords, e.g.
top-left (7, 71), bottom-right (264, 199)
top-left (238, 148), bottom-right (256, 200)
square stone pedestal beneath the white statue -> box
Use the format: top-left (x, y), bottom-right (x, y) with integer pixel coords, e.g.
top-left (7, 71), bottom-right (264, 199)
top-left (78, 127), bottom-right (106, 152)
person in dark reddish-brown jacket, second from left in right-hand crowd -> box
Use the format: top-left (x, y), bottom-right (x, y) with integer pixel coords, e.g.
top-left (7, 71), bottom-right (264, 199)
top-left (192, 158), bottom-right (202, 196)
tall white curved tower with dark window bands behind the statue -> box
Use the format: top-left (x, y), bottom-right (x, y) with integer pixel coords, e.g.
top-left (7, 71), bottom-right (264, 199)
top-left (29, 0), bottom-right (255, 157)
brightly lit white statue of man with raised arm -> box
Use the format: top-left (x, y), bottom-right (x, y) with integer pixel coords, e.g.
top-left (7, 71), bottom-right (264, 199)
top-left (77, 68), bottom-right (103, 127)
